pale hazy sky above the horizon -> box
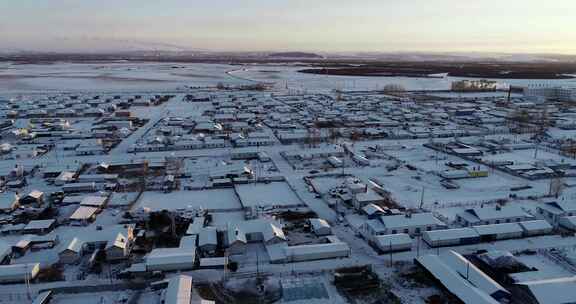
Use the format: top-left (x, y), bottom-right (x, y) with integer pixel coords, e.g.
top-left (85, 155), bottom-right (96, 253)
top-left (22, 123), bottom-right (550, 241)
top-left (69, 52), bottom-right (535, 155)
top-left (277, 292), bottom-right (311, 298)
top-left (0, 0), bottom-right (576, 54)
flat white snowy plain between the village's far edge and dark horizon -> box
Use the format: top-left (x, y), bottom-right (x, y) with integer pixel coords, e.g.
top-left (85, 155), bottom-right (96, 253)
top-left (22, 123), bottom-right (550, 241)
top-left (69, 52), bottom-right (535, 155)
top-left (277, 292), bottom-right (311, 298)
top-left (0, 62), bottom-right (576, 93)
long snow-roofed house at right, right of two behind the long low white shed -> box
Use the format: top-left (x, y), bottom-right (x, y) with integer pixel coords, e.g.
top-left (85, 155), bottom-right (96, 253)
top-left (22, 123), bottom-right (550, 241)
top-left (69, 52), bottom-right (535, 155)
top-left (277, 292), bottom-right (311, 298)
top-left (456, 206), bottom-right (535, 226)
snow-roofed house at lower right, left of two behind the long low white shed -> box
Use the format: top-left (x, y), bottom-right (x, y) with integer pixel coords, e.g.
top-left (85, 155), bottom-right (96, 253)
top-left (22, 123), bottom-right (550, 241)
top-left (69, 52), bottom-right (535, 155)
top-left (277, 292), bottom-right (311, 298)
top-left (380, 212), bottom-right (446, 235)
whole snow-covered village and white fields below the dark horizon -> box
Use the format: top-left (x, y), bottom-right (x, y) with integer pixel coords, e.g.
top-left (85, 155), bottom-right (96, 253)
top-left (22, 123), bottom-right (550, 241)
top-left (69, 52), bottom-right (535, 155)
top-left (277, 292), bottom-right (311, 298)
top-left (0, 59), bottom-right (576, 304)
